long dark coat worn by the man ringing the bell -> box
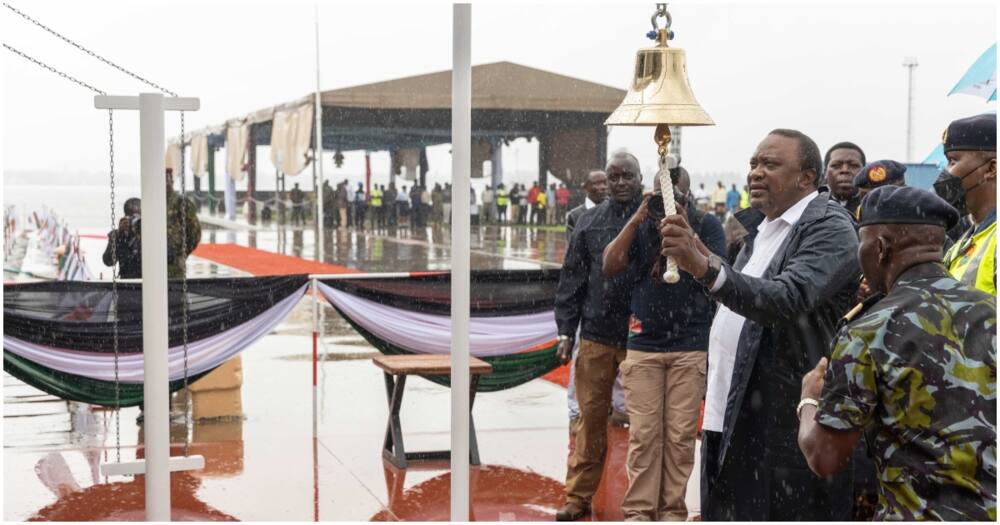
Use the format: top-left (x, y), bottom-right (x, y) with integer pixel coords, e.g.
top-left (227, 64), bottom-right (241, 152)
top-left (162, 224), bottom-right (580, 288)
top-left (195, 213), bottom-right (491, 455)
top-left (703, 192), bottom-right (861, 521)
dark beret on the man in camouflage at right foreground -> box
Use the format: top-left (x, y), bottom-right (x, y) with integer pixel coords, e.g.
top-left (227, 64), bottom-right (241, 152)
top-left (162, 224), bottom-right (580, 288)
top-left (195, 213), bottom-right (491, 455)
top-left (858, 186), bottom-right (959, 230)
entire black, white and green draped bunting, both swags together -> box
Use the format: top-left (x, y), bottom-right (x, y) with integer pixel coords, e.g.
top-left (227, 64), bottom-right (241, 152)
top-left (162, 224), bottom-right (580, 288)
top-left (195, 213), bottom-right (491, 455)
top-left (3, 270), bottom-right (559, 406)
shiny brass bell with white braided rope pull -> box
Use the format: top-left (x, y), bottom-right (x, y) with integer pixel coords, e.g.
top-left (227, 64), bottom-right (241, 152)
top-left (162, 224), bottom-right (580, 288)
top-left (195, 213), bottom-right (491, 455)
top-left (604, 4), bottom-right (715, 283)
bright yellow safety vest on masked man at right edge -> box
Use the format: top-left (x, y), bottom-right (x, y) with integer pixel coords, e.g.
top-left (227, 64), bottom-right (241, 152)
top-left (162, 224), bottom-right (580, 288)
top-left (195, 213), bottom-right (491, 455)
top-left (944, 212), bottom-right (997, 297)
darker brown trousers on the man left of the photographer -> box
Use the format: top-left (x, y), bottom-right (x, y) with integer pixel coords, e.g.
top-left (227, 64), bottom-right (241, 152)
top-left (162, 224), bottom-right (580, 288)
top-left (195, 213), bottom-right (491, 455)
top-left (566, 339), bottom-right (625, 504)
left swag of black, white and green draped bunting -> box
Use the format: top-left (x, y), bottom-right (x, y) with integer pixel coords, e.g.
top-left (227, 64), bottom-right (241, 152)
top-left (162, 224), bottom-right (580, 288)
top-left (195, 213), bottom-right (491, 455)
top-left (3, 275), bottom-right (308, 406)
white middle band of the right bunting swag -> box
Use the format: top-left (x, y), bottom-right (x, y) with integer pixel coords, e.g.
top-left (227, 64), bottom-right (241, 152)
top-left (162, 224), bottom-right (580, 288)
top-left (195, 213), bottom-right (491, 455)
top-left (319, 282), bottom-right (558, 357)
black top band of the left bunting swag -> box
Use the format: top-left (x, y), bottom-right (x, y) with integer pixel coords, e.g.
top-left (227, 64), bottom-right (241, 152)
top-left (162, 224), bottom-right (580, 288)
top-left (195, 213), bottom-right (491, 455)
top-left (3, 275), bottom-right (308, 353)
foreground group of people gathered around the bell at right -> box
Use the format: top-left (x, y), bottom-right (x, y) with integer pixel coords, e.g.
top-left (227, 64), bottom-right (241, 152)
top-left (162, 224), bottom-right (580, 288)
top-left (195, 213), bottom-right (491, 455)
top-left (555, 114), bottom-right (997, 521)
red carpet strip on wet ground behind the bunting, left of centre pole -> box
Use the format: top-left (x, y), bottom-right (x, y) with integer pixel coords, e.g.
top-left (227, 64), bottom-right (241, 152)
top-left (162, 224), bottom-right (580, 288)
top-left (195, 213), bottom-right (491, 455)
top-left (194, 244), bottom-right (361, 275)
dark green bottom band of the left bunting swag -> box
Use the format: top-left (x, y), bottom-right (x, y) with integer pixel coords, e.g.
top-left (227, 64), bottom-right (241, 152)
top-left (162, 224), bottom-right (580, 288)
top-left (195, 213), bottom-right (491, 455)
top-left (3, 351), bottom-right (211, 407)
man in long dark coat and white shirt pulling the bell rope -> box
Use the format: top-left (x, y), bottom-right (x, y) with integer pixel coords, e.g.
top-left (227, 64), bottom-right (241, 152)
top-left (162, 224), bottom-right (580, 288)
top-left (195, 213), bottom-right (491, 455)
top-left (660, 129), bottom-right (860, 521)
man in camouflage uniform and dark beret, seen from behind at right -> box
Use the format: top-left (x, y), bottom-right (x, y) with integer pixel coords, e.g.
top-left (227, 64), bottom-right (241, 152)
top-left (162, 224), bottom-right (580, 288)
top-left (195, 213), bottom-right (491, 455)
top-left (798, 186), bottom-right (997, 521)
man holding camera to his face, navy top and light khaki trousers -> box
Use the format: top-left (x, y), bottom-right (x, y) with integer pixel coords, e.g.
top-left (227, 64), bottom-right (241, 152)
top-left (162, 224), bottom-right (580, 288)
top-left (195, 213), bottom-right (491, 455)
top-left (604, 168), bottom-right (726, 521)
